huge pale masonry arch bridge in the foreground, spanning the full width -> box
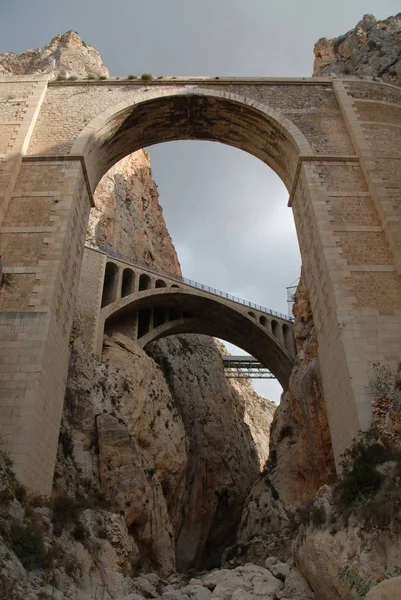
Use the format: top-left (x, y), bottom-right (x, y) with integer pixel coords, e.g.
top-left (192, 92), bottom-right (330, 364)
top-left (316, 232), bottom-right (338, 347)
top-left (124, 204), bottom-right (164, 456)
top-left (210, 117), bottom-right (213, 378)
top-left (0, 76), bottom-right (401, 493)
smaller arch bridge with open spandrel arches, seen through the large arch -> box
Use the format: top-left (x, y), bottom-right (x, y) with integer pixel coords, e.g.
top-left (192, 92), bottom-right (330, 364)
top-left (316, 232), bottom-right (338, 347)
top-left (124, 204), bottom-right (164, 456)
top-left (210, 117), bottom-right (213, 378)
top-left (77, 247), bottom-right (296, 389)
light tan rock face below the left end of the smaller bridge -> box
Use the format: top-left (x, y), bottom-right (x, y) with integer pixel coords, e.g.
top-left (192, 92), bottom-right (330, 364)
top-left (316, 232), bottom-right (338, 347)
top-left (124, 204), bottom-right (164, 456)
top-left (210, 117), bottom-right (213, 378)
top-left (103, 334), bottom-right (188, 530)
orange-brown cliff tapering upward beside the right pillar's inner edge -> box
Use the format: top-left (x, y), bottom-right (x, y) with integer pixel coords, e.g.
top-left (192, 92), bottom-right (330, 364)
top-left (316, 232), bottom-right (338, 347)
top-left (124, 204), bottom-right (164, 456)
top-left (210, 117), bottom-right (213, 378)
top-left (224, 276), bottom-right (335, 565)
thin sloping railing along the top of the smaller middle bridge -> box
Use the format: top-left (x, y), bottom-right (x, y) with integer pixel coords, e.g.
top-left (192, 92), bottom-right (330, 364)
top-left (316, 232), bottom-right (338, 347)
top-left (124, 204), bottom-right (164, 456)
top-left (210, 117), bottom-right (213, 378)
top-left (94, 244), bottom-right (294, 323)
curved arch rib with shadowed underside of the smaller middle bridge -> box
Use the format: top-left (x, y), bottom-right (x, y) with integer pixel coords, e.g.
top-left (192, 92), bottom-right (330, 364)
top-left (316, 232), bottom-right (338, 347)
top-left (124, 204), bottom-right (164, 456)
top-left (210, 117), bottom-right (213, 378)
top-left (99, 288), bottom-right (294, 389)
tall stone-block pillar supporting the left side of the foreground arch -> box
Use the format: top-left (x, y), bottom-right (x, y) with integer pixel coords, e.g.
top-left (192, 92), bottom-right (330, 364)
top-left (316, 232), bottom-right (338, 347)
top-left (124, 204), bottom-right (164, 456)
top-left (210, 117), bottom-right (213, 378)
top-left (0, 159), bottom-right (90, 494)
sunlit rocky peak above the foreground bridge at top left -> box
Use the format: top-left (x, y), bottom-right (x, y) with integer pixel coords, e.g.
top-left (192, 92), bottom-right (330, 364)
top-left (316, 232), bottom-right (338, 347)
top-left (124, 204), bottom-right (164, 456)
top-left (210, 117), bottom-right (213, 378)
top-left (0, 31), bottom-right (109, 79)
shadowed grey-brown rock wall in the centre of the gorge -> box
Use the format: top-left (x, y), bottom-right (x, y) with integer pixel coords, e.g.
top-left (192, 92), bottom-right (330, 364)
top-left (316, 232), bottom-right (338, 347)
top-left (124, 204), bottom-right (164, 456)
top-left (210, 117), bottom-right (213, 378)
top-left (149, 335), bottom-right (259, 569)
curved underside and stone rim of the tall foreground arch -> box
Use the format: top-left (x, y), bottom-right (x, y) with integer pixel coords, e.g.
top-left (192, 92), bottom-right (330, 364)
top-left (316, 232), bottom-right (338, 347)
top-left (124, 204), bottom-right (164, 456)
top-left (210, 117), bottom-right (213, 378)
top-left (70, 86), bottom-right (312, 191)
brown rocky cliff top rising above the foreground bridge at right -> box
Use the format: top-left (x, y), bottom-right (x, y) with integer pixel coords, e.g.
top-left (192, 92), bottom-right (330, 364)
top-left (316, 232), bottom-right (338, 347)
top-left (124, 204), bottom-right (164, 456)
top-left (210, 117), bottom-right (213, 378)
top-left (313, 13), bottom-right (401, 85)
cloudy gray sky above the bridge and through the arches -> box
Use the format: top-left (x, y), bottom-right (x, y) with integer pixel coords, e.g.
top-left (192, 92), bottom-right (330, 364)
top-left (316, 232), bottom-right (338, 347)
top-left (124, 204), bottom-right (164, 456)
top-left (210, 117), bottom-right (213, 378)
top-left (0, 0), bottom-right (400, 401)
